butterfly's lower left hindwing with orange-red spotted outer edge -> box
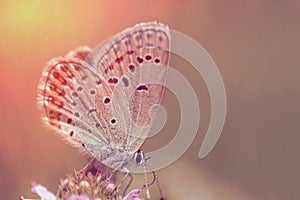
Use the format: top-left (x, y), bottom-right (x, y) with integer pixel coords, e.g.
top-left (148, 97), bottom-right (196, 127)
top-left (38, 47), bottom-right (123, 157)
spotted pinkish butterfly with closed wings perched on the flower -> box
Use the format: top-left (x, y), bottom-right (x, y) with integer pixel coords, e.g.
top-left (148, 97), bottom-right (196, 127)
top-left (37, 22), bottom-right (170, 170)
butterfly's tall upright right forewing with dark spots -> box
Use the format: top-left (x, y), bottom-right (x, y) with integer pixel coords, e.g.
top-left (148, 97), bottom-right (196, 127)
top-left (93, 22), bottom-right (170, 152)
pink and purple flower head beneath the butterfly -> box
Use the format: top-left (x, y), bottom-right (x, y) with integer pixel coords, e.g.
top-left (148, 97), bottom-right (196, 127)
top-left (21, 163), bottom-right (141, 200)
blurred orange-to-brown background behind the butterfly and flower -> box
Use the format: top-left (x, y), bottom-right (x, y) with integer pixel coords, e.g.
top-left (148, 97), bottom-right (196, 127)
top-left (0, 0), bottom-right (300, 200)
